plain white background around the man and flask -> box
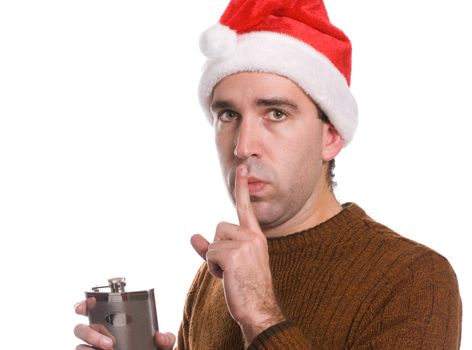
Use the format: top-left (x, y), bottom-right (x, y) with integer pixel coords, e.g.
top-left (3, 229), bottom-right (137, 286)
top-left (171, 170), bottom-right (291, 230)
top-left (0, 0), bottom-right (472, 349)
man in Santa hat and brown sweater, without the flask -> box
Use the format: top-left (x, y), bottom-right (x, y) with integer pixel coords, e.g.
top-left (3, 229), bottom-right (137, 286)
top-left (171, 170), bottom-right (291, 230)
top-left (75, 0), bottom-right (461, 349)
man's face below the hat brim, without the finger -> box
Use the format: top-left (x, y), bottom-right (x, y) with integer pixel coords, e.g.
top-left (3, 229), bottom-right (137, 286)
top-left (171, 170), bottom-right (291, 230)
top-left (211, 73), bottom-right (327, 230)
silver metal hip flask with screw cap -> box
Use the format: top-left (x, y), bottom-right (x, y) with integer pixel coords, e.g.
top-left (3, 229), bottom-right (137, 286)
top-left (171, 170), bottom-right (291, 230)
top-left (85, 277), bottom-right (158, 350)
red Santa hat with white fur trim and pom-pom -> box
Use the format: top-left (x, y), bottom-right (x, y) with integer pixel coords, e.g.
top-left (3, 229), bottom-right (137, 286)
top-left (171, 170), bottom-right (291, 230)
top-left (199, 0), bottom-right (357, 144)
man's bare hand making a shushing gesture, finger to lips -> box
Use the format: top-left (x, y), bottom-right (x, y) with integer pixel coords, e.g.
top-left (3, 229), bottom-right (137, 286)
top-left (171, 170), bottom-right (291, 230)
top-left (191, 165), bottom-right (284, 344)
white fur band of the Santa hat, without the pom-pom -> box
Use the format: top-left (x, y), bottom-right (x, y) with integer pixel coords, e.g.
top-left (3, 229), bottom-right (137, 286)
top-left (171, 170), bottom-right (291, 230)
top-left (199, 28), bottom-right (358, 145)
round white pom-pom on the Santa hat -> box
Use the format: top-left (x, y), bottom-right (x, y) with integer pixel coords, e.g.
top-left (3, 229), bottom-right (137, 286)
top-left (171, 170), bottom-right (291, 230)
top-left (200, 23), bottom-right (238, 59)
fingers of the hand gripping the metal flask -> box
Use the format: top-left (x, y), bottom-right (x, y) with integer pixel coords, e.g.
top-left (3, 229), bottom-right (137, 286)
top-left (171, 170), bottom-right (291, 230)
top-left (74, 298), bottom-right (175, 350)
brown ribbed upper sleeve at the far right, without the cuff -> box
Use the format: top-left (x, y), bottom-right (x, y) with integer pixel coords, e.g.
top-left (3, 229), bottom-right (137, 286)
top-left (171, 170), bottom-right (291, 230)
top-left (351, 252), bottom-right (462, 350)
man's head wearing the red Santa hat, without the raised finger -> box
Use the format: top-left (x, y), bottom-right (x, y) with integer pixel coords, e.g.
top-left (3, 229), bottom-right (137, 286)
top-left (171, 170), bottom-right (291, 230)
top-left (199, 0), bottom-right (357, 234)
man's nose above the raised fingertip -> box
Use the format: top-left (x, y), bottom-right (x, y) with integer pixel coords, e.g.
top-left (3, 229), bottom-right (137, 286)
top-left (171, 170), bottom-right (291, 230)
top-left (234, 118), bottom-right (262, 160)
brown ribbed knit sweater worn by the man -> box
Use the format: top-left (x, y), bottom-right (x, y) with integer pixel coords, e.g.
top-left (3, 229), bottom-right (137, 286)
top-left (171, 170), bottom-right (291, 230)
top-left (178, 204), bottom-right (461, 350)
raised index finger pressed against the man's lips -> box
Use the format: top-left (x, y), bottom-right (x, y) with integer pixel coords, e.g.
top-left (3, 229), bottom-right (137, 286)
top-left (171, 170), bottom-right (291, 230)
top-left (234, 164), bottom-right (261, 232)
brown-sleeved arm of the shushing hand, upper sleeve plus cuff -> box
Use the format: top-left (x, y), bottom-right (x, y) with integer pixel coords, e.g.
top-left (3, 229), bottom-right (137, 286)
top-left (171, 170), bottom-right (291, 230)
top-left (248, 251), bottom-right (462, 350)
